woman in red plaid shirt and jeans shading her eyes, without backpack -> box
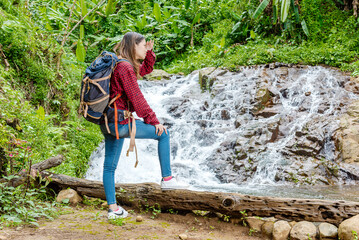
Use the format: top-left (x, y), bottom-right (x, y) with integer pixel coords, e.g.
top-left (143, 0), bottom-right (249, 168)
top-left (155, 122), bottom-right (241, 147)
top-left (100, 32), bottom-right (187, 219)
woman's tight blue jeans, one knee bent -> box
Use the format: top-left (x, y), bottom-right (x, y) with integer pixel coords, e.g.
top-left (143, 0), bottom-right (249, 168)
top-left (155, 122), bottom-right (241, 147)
top-left (100, 120), bottom-right (172, 205)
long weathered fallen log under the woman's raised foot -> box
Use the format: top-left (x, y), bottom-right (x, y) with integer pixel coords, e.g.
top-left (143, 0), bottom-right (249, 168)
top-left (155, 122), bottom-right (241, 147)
top-left (43, 173), bottom-right (359, 224)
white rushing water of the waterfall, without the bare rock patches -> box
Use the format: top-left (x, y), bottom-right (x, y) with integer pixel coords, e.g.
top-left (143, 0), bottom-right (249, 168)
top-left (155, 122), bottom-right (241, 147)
top-left (85, 67), bottom-right (356, 198)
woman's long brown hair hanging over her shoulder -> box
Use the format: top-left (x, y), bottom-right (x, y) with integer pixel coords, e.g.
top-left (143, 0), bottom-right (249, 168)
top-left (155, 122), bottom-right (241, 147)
top-left (113, 32), bottom-right (145, 78)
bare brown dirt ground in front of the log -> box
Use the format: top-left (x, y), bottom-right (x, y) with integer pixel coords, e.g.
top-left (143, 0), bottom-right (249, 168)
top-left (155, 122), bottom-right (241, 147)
top-left (0, 206), bottom-right (263, 240)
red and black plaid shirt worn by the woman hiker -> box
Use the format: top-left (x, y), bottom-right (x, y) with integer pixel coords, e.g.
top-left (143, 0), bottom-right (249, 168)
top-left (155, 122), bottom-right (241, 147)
top-left (110, 50), bottom-right (160, 125)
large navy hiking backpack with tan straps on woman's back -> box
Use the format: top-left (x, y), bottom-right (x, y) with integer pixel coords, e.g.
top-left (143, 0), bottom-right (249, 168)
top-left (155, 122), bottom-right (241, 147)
top-left (78, 51), bottom-right (128, 125)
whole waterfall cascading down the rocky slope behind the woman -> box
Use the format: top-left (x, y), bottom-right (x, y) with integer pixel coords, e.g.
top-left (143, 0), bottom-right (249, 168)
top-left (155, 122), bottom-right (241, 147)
top-left (85, 66), bottom-right (358, 199)
